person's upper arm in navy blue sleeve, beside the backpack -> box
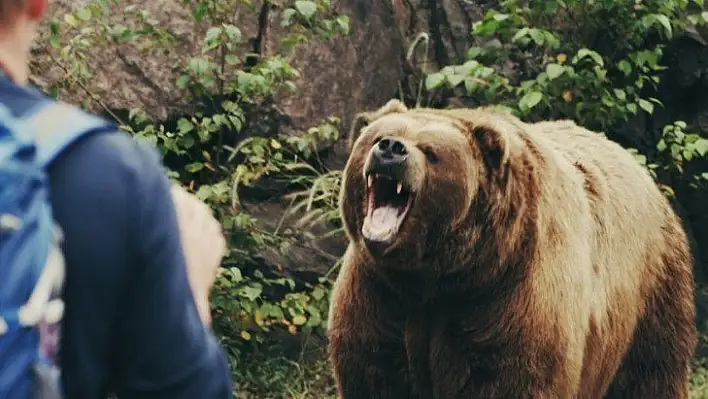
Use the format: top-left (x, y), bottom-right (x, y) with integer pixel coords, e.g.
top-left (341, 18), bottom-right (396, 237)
top-left (50, 133), bottom-right (232, 399)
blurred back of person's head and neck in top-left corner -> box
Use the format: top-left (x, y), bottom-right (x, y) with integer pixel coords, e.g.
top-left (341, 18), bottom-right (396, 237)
top-left (0, 0), bottom-right (49, 83)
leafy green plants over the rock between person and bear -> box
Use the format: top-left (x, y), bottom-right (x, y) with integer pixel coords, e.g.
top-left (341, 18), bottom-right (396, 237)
top-left (40, 0), bottom-right (349, 390)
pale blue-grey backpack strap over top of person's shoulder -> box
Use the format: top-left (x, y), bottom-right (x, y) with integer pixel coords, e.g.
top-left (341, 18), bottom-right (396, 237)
top-left (23, 101), bottom-right (117, 167)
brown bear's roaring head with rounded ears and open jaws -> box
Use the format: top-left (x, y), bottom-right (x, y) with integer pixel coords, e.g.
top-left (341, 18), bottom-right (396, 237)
top-left (340, 100), bottom-right (523, 266)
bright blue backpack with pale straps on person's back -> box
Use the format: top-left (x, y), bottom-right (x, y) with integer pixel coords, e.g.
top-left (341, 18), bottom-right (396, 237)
top-left (0, 97), bottom-right (115, 399)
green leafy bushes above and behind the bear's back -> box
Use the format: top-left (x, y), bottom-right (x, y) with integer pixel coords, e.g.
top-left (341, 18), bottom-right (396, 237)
top-left (425, 0), bottom-right (708, 195)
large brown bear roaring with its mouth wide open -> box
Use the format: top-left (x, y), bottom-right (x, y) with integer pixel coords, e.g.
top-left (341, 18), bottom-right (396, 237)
top-left (328, 100), bottom-right (697, 399)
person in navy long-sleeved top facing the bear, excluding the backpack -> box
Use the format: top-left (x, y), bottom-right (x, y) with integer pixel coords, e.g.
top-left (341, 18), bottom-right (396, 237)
top-left (0, 0), bottom-right (233, 399)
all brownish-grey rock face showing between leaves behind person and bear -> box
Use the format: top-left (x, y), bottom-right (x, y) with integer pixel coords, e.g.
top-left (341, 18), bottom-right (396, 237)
top-left (33, 0), bottom-right (403, 137)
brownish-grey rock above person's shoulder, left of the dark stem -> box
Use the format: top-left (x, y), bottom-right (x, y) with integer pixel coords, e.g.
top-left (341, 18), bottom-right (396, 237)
top-left (32, 0), bottom-right (206, 120)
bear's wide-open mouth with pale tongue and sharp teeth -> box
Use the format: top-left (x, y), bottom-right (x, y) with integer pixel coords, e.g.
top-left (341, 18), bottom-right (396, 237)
top-left (362, 173), bottom-right (413, 244)
